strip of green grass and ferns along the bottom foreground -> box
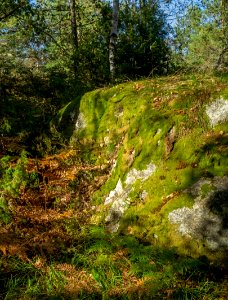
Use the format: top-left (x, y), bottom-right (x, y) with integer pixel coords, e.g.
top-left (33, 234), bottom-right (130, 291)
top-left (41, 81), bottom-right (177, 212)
top-left (0, 226), bottom-right (225, 299)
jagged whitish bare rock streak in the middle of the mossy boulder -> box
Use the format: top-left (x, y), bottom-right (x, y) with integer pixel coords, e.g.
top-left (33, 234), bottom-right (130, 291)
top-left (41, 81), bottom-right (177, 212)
top-left (104, 163), bottom-right (156, 232)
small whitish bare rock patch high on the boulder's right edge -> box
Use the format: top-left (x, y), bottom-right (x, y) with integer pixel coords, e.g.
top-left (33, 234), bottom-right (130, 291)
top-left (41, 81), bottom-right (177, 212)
top-left (206, 98), bottom-right (228, 127)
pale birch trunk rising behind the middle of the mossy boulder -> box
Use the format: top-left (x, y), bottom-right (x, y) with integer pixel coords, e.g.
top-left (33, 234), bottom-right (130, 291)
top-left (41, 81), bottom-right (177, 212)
top-left (109, 0), bottom-right (119, 80)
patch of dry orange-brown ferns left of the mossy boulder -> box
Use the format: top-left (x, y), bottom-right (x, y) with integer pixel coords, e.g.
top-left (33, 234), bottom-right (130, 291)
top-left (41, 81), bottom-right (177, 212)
top-left (0, 150), bottom-right (110, 261)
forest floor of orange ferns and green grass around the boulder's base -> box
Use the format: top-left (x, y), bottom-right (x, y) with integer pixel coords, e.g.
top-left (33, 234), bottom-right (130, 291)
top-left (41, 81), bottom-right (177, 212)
top-left (0, 141), bottom-right (227, 300)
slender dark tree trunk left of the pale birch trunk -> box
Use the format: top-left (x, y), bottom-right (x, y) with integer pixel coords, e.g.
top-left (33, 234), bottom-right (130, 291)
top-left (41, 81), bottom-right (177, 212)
top-left (70, 0), bottom-right (78, 78)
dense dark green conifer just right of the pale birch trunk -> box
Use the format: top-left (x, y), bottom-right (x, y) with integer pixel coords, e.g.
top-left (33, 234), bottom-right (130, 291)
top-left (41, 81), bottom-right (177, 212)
top-left (116, 0), bottom-right (169, 78)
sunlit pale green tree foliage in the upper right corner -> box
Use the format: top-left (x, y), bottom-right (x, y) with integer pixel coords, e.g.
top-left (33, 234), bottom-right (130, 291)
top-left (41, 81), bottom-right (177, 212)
top-left (175, 0), bottom-right (228, 73)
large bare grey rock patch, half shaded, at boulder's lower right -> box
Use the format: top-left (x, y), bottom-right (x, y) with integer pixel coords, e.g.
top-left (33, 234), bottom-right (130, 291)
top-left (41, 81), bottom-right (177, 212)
top-left (169, 176), bottom-right (228, 250)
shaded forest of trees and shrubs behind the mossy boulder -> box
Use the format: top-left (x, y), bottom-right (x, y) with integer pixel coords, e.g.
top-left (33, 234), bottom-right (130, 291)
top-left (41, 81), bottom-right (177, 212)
top-left (0, 0), bottom-right (228, 152)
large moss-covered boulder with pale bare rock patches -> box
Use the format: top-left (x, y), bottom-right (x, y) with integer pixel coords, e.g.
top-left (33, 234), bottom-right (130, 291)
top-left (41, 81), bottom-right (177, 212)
top-left (59, 76), bottom-right (228, 257)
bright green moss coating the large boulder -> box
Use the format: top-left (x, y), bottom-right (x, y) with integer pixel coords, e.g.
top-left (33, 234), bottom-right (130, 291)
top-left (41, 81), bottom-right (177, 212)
top-left (54, 75), bottom-right (228, 253)
